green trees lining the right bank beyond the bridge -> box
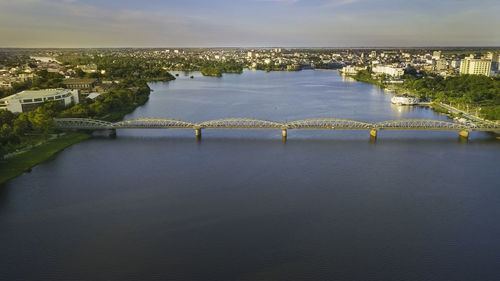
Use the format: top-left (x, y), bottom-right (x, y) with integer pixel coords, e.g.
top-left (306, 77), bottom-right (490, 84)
top-left (350, 69), bottom-right (500, 121)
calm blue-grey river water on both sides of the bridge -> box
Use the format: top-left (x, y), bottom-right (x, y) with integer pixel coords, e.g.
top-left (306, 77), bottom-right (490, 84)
top-left (0, 71), bottom-right (500, 281)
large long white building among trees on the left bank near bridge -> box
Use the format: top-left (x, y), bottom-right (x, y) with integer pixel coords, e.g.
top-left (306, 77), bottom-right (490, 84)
top-left (0, 89), bottom-right (79, 112)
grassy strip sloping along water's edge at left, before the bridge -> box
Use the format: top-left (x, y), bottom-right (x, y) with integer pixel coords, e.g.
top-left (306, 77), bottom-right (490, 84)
top-left (0, 133), bottom-right (90, 184)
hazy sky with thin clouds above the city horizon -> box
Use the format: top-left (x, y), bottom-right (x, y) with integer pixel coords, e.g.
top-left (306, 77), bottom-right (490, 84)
top-left (0, 0), bottom-right (500, 47)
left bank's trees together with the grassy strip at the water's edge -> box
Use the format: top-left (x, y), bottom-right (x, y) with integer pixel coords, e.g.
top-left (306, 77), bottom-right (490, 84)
top-left (0, 56), bottom-right (175, 184)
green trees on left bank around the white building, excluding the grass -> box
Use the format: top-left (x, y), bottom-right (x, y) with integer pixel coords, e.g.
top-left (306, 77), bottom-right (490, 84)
top-left (0, 52), bottom-right (175, 158)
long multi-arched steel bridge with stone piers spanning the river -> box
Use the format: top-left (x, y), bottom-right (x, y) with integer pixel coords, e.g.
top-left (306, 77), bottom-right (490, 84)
top-left (55, 118), bottom-right (500, 138)
